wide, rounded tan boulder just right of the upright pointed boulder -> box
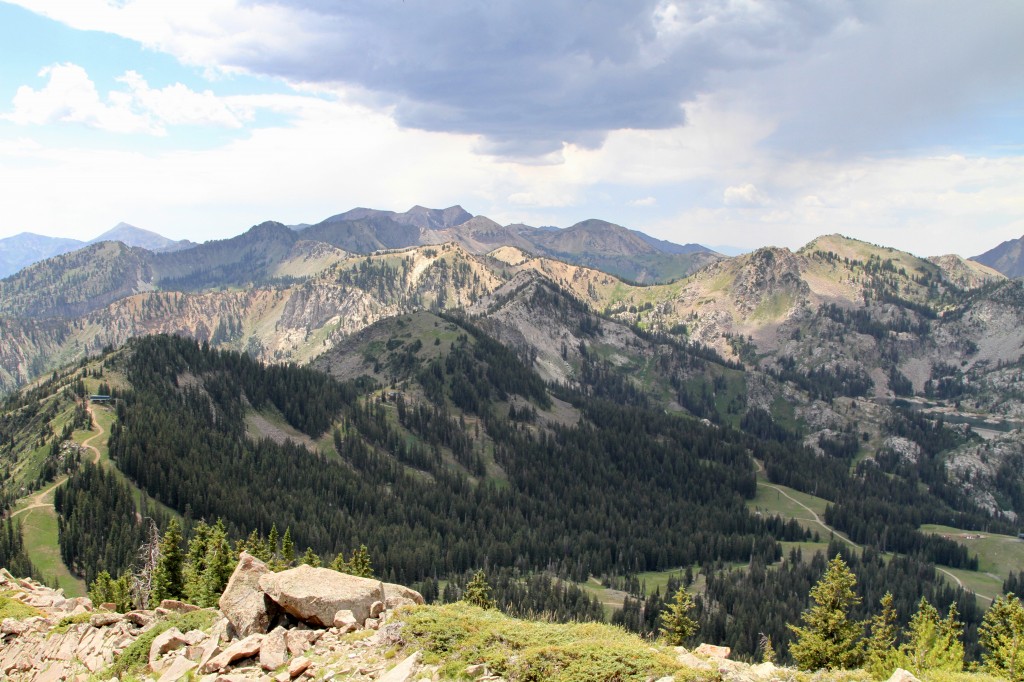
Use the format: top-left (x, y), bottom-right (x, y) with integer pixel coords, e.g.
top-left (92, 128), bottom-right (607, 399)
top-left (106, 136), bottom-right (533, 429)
top-left (259, 564), bottom-right (384, 628)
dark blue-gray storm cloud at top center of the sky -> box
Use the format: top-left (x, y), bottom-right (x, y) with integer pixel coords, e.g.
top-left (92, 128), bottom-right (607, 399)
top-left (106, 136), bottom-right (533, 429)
top-left (232, 0), bottom-right (857, 151)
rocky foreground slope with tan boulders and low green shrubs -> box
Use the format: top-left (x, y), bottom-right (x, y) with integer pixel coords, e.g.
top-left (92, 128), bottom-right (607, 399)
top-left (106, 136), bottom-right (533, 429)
top-left (0, 553), bottom-right (933, 682)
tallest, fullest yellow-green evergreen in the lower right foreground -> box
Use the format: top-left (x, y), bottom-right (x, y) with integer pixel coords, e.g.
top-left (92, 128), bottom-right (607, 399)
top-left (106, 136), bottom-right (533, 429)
top-left (788, 554), bottom-right (863, 671)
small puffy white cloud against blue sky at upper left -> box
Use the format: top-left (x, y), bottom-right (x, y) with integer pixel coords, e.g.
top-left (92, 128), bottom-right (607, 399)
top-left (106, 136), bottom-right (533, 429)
top-left (0, 63), bottom-right (252, 136)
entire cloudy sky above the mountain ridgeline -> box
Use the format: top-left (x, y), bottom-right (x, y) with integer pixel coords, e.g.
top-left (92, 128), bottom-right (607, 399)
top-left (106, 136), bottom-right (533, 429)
top-left (0, 0), bottom-right (1024, 256)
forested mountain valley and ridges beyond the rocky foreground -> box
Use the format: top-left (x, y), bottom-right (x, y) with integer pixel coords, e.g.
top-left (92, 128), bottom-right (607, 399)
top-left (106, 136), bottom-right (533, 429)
top-left (0, 202), bottom-right (1024, 658)
